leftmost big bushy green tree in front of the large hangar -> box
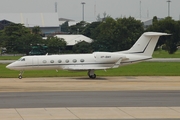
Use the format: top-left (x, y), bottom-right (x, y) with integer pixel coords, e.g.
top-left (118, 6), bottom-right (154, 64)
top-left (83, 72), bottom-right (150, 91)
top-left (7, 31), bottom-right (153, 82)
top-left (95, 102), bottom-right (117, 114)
top-left (0, 23), bottom-right (42, 54)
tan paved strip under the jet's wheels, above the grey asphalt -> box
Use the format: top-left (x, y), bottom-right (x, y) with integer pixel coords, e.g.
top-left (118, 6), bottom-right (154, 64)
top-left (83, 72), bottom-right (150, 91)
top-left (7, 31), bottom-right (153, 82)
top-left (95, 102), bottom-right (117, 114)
top-left (0, 76), bottom-right (180, 92)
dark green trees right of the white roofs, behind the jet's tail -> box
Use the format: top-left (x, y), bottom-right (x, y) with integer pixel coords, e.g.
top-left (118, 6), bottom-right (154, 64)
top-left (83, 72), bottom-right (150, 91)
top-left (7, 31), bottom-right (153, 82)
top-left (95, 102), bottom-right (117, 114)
top-left (69, 16), bottom-right (180, 54)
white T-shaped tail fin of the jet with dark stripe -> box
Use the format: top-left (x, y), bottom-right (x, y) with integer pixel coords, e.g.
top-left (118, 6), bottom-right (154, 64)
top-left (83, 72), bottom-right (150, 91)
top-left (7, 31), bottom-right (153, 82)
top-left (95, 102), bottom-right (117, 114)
top-left (125, 32), bottom-right (170, 56)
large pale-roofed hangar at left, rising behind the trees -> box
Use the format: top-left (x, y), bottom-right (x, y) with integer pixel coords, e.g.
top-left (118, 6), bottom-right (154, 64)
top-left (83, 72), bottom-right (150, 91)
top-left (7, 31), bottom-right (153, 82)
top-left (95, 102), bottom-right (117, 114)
top-left (0, 13), bottom-right (61, 36)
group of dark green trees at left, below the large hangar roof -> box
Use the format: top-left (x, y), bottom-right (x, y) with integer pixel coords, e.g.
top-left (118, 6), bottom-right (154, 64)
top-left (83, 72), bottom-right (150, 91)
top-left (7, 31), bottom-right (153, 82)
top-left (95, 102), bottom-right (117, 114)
top-left (0, 23), bottom-right (66, 55)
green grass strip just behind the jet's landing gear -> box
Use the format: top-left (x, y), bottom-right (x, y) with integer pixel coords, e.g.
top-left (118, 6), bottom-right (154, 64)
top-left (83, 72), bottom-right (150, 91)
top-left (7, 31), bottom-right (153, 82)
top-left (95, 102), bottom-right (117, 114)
top-left (0, 62), bottom-right (180, 78)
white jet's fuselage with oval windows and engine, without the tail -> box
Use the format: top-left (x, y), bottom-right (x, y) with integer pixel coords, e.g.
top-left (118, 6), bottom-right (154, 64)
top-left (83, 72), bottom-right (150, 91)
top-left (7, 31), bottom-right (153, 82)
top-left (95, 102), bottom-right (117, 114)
top-left (7, 52), bottom-right (126, 71)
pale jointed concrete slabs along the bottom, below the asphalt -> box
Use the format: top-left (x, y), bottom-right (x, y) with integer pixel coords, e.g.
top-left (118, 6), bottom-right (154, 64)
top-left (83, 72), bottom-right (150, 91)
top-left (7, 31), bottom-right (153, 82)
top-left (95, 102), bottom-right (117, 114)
top-left (0, 107), bottom-right (180, 120)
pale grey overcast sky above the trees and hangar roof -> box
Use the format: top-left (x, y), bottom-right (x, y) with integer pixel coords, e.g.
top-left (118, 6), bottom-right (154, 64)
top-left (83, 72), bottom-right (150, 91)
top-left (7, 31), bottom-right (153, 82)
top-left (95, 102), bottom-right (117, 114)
top-left (0, 0), bottom-right (180, 22)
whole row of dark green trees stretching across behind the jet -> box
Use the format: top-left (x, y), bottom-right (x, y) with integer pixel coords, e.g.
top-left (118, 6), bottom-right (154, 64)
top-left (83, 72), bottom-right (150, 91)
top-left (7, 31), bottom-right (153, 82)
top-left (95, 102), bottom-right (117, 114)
top-left (0, 17), bottom-right (180, 54)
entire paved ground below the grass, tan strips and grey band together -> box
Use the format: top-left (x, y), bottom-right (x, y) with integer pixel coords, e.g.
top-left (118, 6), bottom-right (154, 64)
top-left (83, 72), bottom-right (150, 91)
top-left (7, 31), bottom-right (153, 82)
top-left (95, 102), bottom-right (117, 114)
top-left (0, 76), bottom-right (180, 120)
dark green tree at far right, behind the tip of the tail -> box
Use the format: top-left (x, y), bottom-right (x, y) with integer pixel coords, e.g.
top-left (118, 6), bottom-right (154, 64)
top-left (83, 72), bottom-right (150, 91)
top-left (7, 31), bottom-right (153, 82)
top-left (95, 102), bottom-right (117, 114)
top-left (147, 17), bottom-right (180, 54)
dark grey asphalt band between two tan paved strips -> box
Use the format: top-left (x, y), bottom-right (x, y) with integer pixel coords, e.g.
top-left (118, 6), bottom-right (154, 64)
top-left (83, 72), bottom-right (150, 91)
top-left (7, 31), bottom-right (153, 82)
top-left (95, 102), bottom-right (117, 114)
top-left (0, 91), bottom-right (180, 109)
